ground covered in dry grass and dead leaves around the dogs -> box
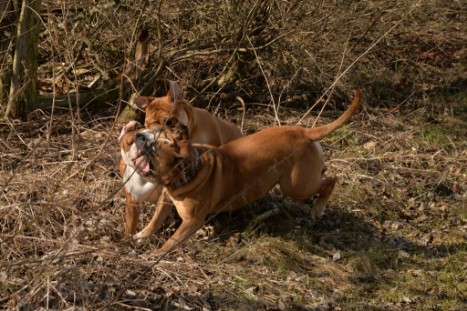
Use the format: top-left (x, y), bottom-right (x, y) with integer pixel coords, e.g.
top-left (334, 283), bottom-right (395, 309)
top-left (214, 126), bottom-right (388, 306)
top-left (0, 86), bottom-right (467, 310)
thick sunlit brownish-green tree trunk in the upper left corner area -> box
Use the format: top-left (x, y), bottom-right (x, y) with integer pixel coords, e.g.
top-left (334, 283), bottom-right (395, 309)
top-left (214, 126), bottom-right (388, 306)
top-left (5, 0), bottom-right (41, 119)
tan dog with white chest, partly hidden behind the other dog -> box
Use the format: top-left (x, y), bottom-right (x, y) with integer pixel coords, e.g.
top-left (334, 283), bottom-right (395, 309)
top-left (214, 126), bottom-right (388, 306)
top-left (119, 81), bottom-right (242, 234)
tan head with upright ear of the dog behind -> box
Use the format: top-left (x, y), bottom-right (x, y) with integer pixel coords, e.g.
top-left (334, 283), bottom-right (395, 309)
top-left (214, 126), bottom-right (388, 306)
top-left (135, 81), bottom-right (193, 129)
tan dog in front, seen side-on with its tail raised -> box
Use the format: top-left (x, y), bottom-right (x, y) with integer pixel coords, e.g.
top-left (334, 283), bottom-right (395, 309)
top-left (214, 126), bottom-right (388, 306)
top-left (125, 91), bottom-right (361, 253)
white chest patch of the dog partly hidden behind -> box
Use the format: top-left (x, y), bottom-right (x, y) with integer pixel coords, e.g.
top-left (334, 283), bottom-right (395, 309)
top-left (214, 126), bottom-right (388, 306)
top-left (123, 165), bottom-right (159, 202)
